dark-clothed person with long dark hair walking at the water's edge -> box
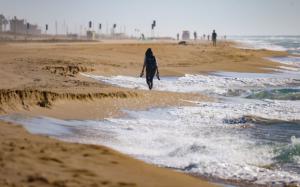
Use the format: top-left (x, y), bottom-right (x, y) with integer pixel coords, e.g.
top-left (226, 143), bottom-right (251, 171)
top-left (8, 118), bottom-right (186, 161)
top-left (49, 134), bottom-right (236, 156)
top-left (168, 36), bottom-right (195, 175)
top-left (140, 48), bottom-right (160, 90)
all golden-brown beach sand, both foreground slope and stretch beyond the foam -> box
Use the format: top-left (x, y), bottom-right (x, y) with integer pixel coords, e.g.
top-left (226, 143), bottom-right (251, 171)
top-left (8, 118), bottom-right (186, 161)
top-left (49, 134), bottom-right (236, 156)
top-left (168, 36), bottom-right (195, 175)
top-left (0, 42), bottom-right (286, 186)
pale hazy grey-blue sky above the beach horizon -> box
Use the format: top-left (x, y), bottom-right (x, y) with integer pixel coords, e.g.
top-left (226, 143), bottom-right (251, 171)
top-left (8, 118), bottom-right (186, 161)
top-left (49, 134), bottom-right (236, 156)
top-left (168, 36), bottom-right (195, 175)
top-left (0, 0), bottom-right (300, 37)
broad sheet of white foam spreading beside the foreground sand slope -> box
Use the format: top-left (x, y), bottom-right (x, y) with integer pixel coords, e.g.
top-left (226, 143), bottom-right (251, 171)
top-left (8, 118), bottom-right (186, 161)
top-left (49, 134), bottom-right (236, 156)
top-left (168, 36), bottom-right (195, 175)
top-left (2, 99), bottom-right (300, 184)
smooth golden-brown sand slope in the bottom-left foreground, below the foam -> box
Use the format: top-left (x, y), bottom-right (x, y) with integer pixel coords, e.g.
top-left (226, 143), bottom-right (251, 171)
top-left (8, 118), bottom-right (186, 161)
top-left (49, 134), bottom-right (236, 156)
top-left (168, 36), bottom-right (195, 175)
top-left (0, 122), bottom-right (215, 187)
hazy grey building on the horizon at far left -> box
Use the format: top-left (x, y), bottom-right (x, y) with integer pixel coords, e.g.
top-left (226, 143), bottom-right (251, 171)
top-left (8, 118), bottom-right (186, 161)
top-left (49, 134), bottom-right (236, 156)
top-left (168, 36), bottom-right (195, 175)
top-left (9, 17), bottom-right (42, 35)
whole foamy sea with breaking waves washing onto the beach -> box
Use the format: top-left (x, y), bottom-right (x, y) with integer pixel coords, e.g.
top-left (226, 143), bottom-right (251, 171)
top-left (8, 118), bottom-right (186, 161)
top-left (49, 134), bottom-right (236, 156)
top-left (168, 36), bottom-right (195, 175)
top-left (0, 36), bottom-right (300, 186)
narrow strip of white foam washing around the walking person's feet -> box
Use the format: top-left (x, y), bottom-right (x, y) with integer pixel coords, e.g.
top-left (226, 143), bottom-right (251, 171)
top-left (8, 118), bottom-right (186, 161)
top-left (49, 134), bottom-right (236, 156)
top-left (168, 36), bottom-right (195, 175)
top-left (82, 72), bottom-right (300, 95)
